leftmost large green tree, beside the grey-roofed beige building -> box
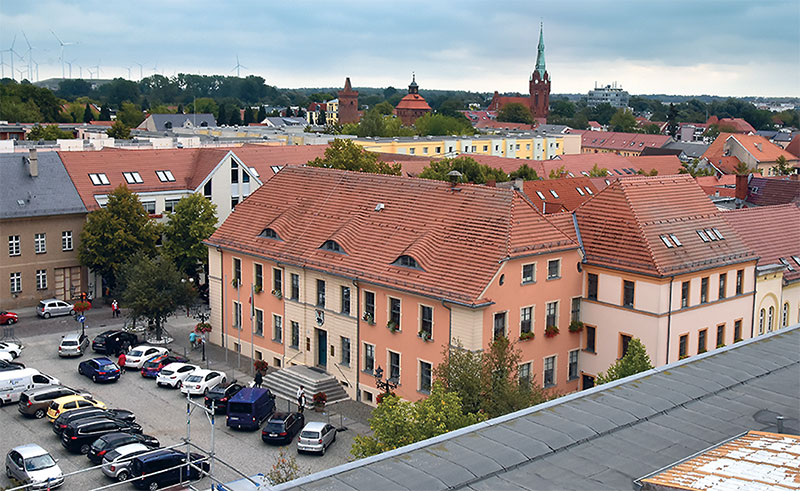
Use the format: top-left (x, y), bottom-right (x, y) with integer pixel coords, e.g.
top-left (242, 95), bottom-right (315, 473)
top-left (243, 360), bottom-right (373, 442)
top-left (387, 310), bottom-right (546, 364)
top-left (78, 185), bottom-right (161, 289)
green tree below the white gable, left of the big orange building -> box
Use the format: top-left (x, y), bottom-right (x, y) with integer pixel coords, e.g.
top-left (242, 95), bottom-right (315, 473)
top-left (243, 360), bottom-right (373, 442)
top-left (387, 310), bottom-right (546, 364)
top-left (163, 193), bottom-right (217, 284)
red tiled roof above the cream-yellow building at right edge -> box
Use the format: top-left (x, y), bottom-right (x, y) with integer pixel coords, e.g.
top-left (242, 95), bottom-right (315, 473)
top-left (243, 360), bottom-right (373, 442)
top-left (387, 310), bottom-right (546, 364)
top-left (723, 204), bottom-right (800, 281)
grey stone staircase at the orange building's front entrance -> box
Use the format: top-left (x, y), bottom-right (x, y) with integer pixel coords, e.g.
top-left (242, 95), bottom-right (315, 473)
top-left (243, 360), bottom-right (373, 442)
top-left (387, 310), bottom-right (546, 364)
top-left (263, 365), bottom-right (350, 408)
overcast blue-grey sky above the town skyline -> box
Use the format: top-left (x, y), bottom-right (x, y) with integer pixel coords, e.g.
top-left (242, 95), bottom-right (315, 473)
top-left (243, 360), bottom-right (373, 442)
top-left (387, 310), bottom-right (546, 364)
top-left (0, 0), bottom-right (800, 96)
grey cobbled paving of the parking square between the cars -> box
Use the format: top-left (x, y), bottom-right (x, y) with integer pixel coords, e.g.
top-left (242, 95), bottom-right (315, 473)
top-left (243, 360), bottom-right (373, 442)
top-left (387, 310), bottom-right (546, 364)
top-left (0, 308), bottom-right (366, 490)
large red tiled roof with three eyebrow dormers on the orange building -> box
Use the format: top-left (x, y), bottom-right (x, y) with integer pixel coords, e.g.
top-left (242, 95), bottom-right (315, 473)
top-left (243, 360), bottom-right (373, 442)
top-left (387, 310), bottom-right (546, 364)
top-left (208, 167), bottom-right (577, 304)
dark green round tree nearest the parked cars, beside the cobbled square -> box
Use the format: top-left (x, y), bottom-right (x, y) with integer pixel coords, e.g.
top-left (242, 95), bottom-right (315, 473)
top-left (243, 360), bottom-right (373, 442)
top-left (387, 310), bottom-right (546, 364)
top-left (119, 252), bottom-right (196, 340)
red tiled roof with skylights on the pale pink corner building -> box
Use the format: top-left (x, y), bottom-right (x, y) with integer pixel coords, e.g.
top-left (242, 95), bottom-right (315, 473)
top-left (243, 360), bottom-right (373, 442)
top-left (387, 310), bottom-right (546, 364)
top-left (575, 175), bottom-right (754, 277)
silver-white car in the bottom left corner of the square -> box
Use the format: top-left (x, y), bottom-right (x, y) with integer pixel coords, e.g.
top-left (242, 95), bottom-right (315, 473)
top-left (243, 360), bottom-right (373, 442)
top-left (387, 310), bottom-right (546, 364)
top-left (6, 443), bottom-right (64, 489)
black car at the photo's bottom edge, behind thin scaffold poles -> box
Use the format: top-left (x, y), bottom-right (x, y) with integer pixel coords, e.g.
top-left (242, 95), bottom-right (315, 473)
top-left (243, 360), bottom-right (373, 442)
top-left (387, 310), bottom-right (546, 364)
top-left (131, 449), bottom-right (209, 490)
